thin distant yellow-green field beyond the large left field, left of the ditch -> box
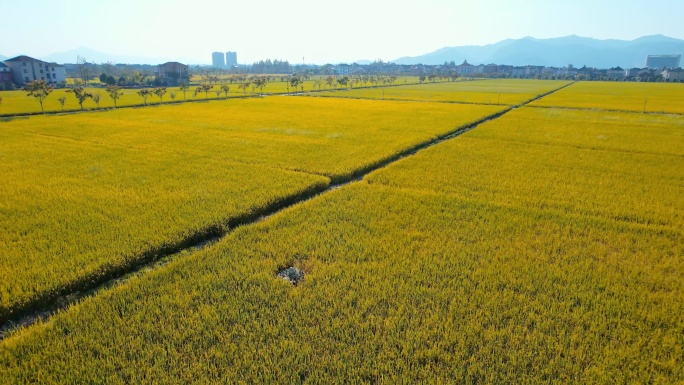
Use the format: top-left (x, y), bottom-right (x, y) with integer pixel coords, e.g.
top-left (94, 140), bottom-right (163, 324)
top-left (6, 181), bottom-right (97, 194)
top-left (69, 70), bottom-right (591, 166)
top-left (317, 79), bottom-right (570, 105)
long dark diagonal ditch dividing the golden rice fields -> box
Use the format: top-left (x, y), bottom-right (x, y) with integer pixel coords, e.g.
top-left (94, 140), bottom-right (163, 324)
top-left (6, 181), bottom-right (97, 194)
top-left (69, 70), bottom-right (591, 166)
top-left (0, 82), bottom-right (574, 340)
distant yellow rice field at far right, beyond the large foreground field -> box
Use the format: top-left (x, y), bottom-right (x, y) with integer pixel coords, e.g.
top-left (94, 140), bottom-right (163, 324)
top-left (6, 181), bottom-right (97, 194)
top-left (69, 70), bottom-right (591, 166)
top-left (532, 82), bottom-right (684, 114)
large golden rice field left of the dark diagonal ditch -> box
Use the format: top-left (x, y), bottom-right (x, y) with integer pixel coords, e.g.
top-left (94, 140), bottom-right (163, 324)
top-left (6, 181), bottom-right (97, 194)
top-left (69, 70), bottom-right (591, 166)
top-left (0, 97), bottom-right (500, 320)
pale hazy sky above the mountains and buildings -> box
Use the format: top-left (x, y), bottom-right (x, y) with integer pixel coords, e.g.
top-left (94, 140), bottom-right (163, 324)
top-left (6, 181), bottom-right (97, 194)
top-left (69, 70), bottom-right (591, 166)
top-left (0, 0), bottom-right (684, 64)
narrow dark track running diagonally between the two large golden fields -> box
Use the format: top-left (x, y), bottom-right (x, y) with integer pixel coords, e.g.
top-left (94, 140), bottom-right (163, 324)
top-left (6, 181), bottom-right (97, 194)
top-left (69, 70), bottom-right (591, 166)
top-left (0, 82), bottom-right (574, 340)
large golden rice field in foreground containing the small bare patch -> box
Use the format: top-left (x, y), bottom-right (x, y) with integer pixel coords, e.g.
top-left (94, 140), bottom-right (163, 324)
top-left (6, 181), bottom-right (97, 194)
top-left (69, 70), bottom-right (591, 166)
top-left (0, 104), bottom-right (684, 384)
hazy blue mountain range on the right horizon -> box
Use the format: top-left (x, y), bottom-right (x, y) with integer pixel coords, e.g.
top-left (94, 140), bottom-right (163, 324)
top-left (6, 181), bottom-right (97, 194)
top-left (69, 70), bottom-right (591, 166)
top-left (393, 35), bottom-right (684, 68)
